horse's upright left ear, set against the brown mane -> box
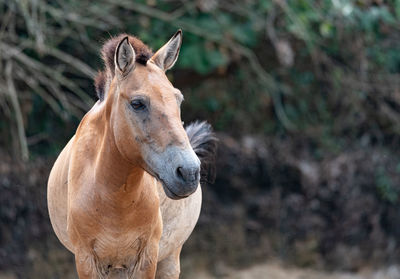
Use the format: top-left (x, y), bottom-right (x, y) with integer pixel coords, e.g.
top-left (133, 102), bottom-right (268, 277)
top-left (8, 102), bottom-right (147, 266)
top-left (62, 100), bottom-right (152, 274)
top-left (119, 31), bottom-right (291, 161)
top-left (114, 36), bottom-right (136, 75)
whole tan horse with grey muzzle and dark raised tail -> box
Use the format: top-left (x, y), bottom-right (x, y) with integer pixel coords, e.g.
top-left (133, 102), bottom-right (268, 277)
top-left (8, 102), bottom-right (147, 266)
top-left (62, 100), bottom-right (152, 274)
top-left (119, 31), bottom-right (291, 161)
top-left (47, 30), bottom-right (216, 279)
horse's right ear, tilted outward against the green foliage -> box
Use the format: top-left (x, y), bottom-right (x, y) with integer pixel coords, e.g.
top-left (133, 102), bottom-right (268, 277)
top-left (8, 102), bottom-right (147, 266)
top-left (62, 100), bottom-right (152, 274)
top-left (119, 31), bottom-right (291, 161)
top-left (151, 29), bottom-right (182, 71)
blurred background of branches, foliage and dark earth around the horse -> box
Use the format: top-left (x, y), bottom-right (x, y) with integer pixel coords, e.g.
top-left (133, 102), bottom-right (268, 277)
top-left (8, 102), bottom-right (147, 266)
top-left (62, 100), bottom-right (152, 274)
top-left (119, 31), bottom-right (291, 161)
top-left (0, 0), bottom-right (400, 279)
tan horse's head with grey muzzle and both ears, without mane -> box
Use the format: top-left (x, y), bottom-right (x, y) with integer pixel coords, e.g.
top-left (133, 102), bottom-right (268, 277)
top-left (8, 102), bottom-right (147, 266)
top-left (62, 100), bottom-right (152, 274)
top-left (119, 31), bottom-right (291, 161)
top-left (107, 30), bottom-right (200, 199)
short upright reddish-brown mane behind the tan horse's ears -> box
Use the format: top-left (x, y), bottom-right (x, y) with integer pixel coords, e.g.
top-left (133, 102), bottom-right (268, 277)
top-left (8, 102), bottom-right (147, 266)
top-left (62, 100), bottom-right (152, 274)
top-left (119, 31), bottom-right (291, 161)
top-left (94, 34), bottom-right (153, 101)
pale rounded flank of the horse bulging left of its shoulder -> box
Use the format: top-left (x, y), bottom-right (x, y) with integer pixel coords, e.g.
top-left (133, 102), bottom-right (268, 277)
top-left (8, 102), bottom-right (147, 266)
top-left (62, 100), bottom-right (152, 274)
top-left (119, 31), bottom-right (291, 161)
top-left (47, 136), bottom-right (75, 252)
